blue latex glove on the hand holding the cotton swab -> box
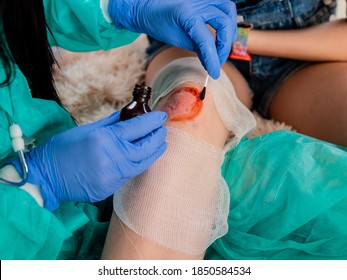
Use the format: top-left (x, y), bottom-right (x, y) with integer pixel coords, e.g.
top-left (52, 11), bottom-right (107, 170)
top-left (109, 0), bottom-right (237, 79)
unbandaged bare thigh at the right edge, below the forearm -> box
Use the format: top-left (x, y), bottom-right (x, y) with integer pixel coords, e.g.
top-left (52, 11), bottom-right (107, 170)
top-left (269, 62), bottom-right (347, 146)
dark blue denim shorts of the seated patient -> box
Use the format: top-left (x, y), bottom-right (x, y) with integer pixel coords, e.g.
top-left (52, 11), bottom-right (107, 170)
top-left (147, 0), bottom-right (336, 118)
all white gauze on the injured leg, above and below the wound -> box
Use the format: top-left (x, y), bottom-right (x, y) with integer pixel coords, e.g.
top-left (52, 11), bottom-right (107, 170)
top-left (114, 58), bottom-right (255, 255)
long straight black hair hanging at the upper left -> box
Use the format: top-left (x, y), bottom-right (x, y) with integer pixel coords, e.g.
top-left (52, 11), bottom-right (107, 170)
top-left (0, 0), bottom-right (61, 105)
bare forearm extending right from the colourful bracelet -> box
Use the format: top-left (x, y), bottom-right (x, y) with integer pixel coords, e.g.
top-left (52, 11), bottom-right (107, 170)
top-left (248, 19), bottom-right (347, 61)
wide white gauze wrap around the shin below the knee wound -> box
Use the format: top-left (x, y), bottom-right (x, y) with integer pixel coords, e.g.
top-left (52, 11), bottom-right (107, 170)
top-left (114, 127), bottom-right (229, 255)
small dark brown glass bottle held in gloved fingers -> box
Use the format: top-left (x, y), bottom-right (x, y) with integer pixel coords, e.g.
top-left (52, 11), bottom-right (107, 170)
top-left (119, 84), bottom-right (152, 121)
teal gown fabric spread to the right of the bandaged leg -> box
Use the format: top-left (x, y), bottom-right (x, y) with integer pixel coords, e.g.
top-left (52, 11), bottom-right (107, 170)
top-left (206, 131), bottom-right (347, 260)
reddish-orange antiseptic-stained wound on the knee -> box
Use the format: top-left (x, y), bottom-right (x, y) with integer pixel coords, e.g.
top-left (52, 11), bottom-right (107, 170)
top-left (160, 87), bottom-right (203, 122)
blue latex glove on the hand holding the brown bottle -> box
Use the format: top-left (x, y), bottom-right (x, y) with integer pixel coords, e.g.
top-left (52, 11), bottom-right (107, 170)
top-left (14, 111), bottom-right (167, 210)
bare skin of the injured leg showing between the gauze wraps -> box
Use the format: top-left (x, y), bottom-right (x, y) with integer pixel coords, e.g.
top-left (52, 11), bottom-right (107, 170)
top-left (102, 48), bottom-right (250, 259)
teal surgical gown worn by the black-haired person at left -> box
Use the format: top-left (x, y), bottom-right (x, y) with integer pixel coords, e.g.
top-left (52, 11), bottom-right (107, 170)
top-left (0, 0), bottom-right (138, 259)
